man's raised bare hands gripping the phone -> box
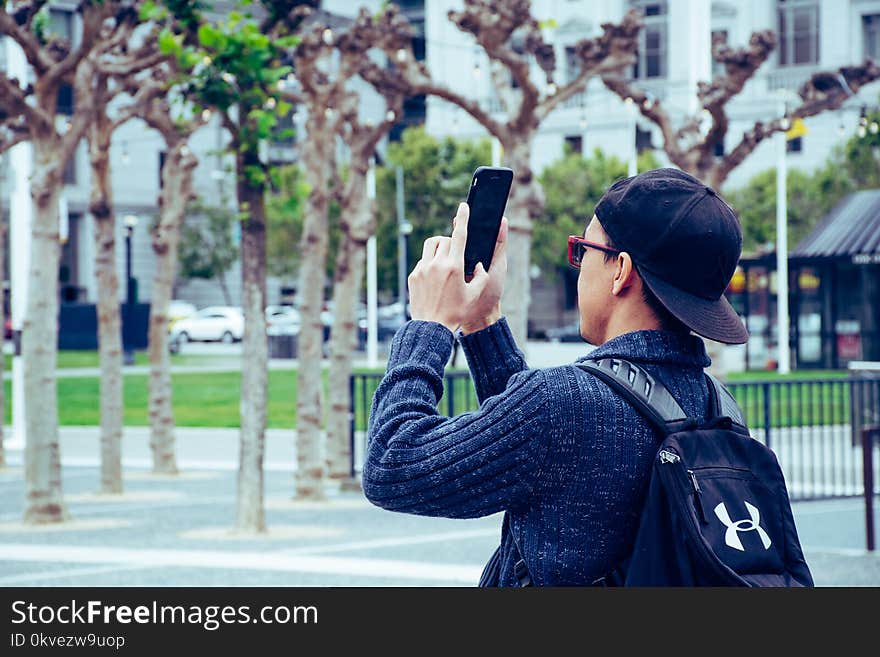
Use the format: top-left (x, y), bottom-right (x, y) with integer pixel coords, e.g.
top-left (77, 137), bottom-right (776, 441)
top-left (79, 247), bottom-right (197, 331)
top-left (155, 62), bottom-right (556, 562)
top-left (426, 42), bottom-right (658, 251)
top-left (407, 203), bottom-right (507, 332)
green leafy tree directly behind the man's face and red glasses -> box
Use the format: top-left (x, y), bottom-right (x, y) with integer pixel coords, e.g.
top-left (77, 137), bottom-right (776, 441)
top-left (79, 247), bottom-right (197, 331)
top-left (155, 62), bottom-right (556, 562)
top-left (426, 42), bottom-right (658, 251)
top-left (532, 148), bottom-right (659, 273)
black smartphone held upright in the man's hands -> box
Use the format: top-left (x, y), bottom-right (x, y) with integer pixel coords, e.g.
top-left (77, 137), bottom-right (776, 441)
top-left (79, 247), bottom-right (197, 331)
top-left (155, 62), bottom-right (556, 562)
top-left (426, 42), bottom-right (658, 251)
top-left (464, 167), bottom-right (513, 276)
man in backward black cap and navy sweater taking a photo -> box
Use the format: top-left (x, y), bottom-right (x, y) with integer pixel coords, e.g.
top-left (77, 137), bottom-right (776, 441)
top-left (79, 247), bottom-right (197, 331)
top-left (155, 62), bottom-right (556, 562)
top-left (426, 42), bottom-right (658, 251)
top-left (363, 169), bottom-right (748, 586)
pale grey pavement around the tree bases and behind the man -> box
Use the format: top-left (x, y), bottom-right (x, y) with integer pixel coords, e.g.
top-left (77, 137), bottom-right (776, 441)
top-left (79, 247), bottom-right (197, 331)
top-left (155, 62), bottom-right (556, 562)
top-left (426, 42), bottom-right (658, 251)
top-left (0, 427), bottom-right (880, 587)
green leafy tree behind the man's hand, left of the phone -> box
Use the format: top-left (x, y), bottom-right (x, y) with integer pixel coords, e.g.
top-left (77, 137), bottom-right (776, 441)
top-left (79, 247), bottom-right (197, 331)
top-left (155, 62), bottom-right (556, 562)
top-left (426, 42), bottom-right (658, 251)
top-left (376, 127), bottom-right (491, 298)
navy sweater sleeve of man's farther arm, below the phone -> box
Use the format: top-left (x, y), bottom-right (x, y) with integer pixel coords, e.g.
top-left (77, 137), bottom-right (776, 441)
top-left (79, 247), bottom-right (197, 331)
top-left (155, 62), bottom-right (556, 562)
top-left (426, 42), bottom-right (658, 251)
top-left (458, 317), bottom-right (527, 404)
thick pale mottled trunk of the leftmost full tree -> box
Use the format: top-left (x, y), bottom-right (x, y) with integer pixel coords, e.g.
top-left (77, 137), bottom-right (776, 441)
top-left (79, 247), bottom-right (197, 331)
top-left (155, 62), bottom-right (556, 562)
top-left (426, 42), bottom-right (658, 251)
top-left (21, 136), bottom-right (67, 524)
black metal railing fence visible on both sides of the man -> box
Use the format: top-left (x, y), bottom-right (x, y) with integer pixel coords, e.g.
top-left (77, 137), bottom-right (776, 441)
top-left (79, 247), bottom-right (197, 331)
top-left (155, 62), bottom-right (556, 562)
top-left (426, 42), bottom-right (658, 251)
top-left (351, 371), bottom-right (880, 500)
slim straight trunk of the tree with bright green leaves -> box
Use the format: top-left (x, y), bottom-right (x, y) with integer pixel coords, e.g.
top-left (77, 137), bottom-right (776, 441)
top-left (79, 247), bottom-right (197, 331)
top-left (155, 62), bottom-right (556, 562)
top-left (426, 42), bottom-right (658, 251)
top-left (235, 145), bottom-right (269, 532)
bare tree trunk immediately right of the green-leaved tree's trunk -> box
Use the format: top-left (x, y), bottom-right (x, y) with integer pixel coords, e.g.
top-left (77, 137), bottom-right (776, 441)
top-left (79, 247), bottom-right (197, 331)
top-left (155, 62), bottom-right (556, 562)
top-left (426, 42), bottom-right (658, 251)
top-left (295, 118), bottom-right (332, 499)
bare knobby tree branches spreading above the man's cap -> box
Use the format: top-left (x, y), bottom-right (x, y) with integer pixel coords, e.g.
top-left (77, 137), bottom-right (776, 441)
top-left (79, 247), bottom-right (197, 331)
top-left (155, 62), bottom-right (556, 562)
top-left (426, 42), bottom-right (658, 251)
top-left (602, 30), bottom-right (880, 188)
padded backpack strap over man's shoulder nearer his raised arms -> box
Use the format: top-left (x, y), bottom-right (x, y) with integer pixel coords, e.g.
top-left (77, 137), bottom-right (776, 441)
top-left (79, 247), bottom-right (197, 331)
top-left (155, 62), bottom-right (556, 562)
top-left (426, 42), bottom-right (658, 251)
top-left (575, 358), bottom-right (696, 436)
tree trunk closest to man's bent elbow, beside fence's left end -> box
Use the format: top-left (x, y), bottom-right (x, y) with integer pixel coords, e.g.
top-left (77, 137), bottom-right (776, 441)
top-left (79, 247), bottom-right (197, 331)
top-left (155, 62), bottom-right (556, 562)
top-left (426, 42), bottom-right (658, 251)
top-left (327, 165), bottom-right (375, 480)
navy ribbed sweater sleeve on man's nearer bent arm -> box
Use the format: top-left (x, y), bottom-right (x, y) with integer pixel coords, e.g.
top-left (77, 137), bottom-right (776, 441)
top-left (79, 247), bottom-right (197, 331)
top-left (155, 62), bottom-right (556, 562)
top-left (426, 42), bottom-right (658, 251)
top-left (363, 320), bottom-right (551, 518)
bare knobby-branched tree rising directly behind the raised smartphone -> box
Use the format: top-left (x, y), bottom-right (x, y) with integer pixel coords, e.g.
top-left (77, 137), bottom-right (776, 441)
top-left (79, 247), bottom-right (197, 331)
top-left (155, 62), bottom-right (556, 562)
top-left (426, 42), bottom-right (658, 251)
top-left (362, 0), bottom-right (642, 345)
